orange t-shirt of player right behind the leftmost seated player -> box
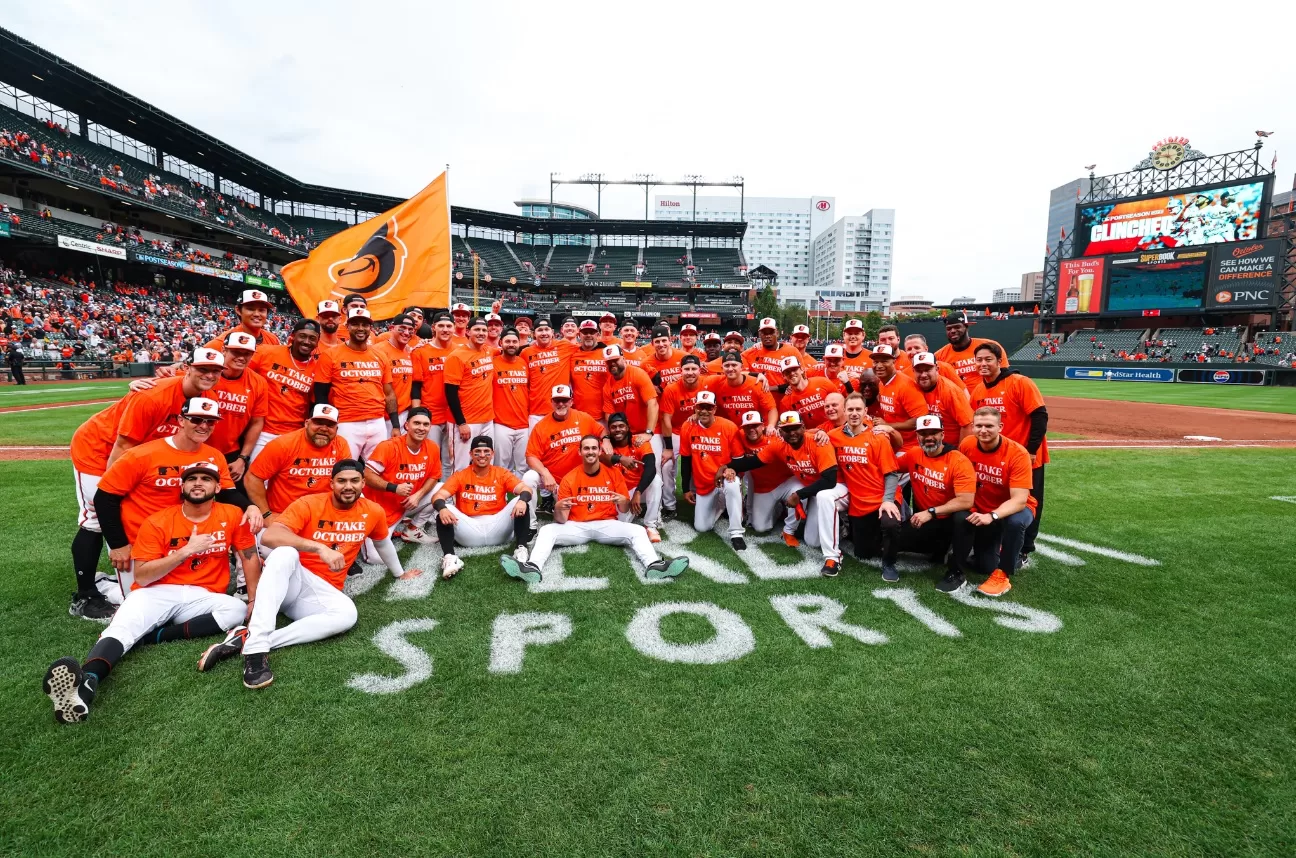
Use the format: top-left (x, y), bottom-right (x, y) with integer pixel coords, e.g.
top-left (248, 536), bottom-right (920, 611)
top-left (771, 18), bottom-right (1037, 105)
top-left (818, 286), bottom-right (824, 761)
top-left (98, 438), bottom-right (242, 543)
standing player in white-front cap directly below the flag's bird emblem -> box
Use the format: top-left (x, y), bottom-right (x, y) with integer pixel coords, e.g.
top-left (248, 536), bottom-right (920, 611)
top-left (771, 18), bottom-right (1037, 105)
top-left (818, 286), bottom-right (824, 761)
top-left (315, 306), bottom-right (400, 458)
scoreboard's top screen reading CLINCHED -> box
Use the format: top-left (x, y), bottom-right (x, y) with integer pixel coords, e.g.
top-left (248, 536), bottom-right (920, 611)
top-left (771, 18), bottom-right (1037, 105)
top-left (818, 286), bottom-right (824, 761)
top-left (1072, 181), bottom-right (1265, 257)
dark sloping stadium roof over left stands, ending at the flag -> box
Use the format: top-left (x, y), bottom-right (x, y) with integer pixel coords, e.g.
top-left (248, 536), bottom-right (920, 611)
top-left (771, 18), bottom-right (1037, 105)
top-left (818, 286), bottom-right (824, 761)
top-left (0, 27), bottom-right (402, 211)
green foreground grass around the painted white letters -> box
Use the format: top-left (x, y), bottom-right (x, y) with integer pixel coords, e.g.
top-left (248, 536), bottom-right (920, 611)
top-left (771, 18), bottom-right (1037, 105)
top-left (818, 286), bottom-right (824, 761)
top-left (0, 450), bottom-right (1296, 857)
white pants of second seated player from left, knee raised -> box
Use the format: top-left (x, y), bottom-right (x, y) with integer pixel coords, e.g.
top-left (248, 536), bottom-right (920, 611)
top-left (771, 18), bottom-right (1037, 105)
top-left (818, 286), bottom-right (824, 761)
top-left (244, 546), bottom-right (358, 656)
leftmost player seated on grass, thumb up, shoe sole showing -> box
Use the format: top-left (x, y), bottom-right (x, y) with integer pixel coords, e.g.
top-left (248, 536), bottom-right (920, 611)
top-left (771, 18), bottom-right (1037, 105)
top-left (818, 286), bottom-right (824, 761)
top-left (41, 461), bottom-right (260, 725)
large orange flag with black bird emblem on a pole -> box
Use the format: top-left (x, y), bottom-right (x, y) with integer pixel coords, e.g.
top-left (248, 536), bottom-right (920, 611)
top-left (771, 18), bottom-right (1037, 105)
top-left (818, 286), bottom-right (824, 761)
top-left (281, 174), bottom-right (451, 319)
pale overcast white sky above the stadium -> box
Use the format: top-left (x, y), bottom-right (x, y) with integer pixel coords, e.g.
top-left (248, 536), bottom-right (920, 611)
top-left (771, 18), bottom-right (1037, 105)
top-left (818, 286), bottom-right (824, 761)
top-left (0, 0), bottom-right (1296, 302)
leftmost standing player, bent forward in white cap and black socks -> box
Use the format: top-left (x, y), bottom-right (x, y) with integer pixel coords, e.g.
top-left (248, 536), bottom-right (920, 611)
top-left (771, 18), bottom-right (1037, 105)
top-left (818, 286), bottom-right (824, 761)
top-left (67, 349), bottom-right (226, 622)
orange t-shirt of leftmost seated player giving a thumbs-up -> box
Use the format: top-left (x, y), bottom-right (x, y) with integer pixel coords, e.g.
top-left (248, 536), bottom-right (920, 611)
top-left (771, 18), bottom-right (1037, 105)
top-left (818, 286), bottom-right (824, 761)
top-left (131, 493), bottom-right (257, 594)
